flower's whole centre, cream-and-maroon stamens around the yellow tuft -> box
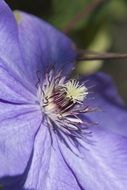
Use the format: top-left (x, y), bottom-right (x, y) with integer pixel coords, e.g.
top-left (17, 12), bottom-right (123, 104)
top-left (38, 70), bottom-right (89, 136)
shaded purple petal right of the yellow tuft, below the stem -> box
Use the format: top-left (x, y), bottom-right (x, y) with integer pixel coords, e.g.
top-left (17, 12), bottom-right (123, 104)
top-left (85, 73), bottom-right (127, 136)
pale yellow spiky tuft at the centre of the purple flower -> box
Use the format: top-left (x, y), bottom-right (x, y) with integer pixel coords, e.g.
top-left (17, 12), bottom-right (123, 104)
top-left (65, 79), bottom-right (88, 102)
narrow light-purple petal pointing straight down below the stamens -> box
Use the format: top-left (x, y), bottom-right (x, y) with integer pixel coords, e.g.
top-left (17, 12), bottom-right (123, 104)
top-left (24, 126), bottom-right (83, 190)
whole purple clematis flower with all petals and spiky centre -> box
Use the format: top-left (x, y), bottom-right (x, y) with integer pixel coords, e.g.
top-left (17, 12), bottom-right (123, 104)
top-left (0, 0), bottom-right (127, 190)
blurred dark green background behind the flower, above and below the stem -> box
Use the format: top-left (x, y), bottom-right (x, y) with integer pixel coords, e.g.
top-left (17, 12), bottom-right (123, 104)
top-left (6, 0), bottom-right (127, 102)
